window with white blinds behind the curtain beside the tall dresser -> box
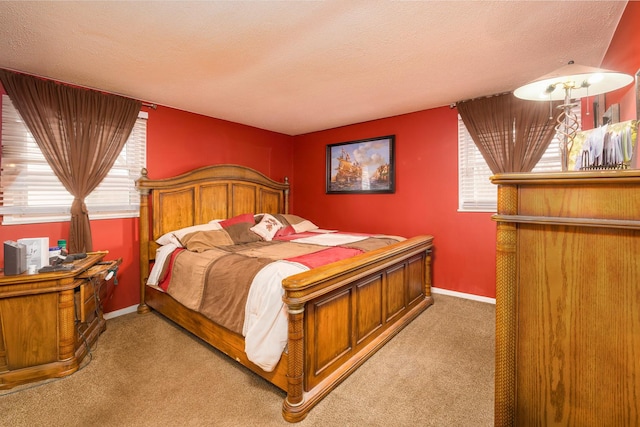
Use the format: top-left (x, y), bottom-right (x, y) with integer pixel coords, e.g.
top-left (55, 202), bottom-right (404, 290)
top-left (458, 103), bottom-right (581, 212)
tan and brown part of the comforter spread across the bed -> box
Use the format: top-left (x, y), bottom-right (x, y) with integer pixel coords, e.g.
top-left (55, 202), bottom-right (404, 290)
top-left (165, 231), bottom-right (397, 334)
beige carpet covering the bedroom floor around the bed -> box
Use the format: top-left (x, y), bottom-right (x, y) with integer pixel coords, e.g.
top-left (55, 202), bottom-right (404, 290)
top-left (0, 294), bottom-right (495, 427)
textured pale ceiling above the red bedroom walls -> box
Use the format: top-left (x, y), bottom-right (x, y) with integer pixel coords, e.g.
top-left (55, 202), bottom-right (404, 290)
top-left (0, 0), bottom-right (626, 135)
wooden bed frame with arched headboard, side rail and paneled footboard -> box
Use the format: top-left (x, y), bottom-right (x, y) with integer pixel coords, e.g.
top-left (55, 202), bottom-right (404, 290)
top-left (137, 165), bottom-right (433, 422)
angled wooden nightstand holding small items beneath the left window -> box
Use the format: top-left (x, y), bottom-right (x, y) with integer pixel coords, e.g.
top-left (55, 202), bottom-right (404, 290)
top-left (0, 253), bottom-right (122, 389)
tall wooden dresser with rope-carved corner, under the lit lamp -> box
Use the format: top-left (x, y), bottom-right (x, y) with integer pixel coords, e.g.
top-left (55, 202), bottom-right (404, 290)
top-left (491, 170), bottom-right (640, 426)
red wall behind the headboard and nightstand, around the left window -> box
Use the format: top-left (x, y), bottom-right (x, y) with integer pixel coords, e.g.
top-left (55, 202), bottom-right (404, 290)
top-left (0, 90), bottom-right (293, 312)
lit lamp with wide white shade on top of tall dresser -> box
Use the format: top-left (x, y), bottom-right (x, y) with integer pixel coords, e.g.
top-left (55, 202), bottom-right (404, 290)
top-left (513, 61), bottom-right (633, 171)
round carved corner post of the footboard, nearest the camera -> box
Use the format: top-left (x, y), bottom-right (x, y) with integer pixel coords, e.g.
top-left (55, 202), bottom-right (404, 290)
top-left (282, 303), bottom-right (306, 422)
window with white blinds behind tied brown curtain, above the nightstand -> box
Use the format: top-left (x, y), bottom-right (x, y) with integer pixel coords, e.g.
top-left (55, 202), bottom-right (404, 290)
top-left (0, 95), bottom-right (148, 225)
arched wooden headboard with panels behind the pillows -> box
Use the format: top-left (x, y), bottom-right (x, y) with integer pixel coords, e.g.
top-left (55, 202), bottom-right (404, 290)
top-left (136, 165), bottom-right (289, 286)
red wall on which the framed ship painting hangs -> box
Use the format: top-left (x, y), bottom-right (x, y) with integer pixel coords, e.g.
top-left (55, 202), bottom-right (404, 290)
top-left (292, 107), bottom-right (496, 297)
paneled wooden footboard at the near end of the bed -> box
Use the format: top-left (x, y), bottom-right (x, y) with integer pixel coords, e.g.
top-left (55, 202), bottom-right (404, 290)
top-left (282, 236), bottom-right (433, 422)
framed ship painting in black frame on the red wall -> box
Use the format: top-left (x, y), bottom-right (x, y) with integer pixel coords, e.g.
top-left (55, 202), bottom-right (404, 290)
top-left (327, 135), bottom-right (395, 194)
